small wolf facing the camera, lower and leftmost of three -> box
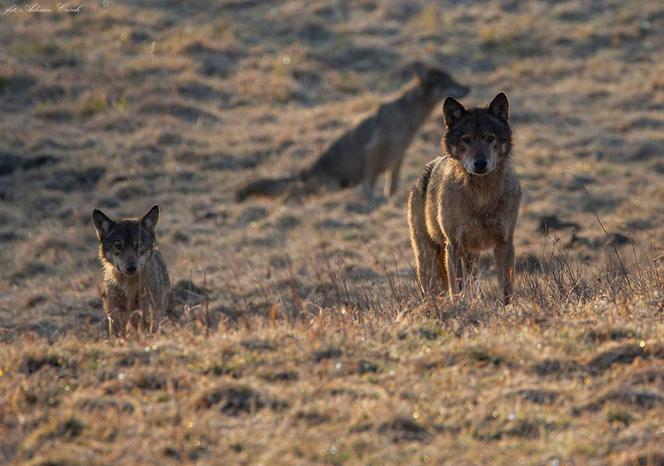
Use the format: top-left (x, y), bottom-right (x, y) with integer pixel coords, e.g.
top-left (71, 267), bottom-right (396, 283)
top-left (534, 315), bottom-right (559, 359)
top-left (92, 205), bottom-right (170, 335)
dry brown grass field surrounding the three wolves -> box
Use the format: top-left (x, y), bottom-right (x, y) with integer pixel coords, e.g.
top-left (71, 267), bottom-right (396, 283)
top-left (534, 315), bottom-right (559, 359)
top-left (0, 0), bottom-right (664, 466)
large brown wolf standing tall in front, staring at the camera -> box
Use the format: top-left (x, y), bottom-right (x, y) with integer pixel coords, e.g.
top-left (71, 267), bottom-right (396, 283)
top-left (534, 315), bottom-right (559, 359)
top-left (408, 93), bottom-right (521, 304)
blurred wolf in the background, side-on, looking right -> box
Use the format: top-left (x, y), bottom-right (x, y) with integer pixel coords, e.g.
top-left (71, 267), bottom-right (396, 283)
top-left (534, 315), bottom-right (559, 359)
top-left (236, 63), bottom-right (468, 201)
